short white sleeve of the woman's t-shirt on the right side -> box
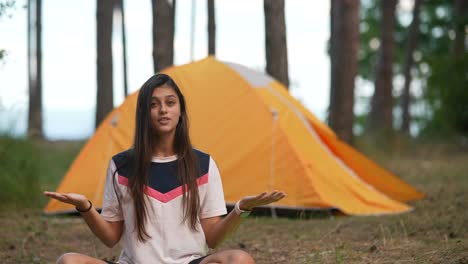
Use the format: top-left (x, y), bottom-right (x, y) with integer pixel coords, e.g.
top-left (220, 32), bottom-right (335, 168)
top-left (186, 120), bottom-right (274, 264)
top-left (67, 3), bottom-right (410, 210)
top-left (200, 157), bottom-right (227, 219)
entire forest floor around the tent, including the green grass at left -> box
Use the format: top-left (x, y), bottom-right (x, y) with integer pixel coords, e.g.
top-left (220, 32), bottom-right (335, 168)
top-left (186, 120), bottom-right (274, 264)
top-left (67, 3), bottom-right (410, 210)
top-left (0, 135), bottom-right (468, 264)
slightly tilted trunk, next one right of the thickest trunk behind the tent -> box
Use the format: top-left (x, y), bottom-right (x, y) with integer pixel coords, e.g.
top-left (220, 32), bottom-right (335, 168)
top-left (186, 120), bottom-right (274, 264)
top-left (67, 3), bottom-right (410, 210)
top-left (369, 0), bottom-right (397, 132)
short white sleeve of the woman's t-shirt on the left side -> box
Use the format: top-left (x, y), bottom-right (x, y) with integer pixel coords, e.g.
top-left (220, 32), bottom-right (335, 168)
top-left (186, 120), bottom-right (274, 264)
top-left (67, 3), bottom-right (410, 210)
top-left (101, 160), bottom-right (123, 222)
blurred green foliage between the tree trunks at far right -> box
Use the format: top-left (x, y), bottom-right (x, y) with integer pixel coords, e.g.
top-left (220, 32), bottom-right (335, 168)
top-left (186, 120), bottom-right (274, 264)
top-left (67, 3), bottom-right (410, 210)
top-left (358, 0), bottom-right (468, 135)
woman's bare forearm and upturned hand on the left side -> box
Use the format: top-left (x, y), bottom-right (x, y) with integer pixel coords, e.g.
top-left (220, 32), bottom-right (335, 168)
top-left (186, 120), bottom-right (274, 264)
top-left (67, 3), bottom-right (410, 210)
top-left (44, 192), bottom-right (123, 248)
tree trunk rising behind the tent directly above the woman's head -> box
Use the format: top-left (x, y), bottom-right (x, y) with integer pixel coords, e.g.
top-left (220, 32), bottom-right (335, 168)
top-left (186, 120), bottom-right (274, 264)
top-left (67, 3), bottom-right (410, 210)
top-left (151, 0), bottom-right (176, 72)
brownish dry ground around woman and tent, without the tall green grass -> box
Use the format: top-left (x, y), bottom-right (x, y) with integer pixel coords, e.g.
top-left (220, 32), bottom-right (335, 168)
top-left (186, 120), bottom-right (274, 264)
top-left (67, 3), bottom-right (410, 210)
top-left (0, 142), bottom-right (468, 264)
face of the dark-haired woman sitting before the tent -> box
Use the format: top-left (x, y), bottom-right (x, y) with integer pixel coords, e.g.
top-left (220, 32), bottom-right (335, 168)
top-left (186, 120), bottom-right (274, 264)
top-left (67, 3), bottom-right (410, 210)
top-left (151, 86), bottom-right (181, 135)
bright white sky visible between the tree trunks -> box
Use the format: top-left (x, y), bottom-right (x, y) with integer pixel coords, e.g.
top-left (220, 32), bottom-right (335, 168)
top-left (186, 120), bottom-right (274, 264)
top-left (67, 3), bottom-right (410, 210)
top-left (0, 0), bottom-right (330, 139)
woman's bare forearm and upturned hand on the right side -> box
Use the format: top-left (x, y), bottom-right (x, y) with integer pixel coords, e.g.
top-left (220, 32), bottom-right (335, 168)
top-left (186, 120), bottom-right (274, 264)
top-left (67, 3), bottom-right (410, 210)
top-left (200, 191), bottom-right (286, 248)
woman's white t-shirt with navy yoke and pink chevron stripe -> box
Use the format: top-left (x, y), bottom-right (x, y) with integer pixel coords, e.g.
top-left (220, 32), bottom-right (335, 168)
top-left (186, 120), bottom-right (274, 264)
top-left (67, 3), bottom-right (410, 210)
top-left (101, 149), bottom-right (227, 264)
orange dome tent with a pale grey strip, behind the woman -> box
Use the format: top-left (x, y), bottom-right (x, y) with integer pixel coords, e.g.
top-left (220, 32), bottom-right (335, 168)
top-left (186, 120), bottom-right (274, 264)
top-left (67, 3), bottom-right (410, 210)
top-left (44, 57), bottom-right (424, 215)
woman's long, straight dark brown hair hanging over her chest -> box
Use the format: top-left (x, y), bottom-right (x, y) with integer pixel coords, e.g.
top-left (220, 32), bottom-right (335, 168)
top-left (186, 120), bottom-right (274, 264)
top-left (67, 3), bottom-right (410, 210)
top-left (129, 73), bottom-right (200, 241)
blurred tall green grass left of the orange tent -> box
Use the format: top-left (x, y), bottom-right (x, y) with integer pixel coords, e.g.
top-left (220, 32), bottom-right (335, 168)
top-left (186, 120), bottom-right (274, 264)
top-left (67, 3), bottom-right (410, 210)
top-left (0, 135), bottom-right (82, 209)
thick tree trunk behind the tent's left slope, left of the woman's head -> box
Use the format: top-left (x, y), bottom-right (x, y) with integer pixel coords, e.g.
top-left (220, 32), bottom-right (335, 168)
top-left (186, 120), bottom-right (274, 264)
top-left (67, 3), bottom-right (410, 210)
top-left (96, 0), bottom-right (114, 128)
